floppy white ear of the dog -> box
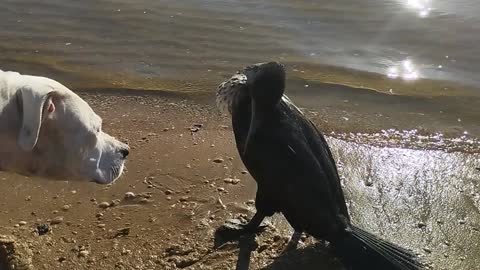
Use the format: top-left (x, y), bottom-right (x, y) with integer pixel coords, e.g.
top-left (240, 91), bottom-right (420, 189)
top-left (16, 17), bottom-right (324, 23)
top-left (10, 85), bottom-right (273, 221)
top-left (18, 86), bottom-right (55, 151)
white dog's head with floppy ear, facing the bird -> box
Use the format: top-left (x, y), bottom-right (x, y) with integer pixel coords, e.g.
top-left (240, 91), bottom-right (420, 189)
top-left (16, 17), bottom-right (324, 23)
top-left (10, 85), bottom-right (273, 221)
top-left (0, 70), bottom-right (129, 184)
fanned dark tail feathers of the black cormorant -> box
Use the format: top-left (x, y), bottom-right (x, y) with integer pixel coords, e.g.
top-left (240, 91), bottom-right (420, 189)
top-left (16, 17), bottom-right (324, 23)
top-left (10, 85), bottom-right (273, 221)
top-left (335, 225), bottom-right (423, 270)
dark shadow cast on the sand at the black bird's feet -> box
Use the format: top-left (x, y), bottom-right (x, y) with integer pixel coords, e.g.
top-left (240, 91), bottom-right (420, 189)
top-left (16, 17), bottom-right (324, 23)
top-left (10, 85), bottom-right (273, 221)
top-left (216, 230), bottom-right (345, 270)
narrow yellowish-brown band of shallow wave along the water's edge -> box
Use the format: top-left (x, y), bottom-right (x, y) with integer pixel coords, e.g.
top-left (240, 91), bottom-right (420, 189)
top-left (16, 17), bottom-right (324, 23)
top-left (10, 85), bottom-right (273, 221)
top-left (0, 51), bottom-right (480, 97)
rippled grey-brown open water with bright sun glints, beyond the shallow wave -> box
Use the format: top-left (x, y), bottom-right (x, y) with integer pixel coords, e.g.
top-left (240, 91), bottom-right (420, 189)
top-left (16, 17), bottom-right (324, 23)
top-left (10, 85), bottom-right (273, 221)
top-left (0, 0), bottom-right (480, 84)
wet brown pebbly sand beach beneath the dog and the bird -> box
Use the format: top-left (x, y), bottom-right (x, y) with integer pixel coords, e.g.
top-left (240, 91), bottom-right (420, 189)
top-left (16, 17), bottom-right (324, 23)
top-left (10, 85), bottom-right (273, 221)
top-left (0, 90), bottom-right (480, 270)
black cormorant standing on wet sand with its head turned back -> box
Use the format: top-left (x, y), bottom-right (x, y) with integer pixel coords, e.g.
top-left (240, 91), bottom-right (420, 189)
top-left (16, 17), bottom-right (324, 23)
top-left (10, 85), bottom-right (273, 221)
top-left (217, 62), bottom-right (422, 270)
